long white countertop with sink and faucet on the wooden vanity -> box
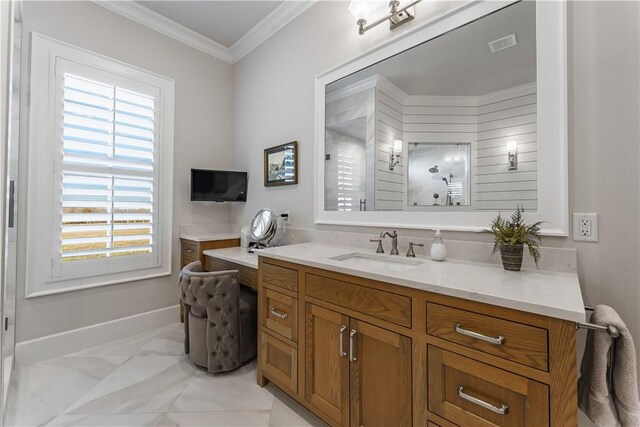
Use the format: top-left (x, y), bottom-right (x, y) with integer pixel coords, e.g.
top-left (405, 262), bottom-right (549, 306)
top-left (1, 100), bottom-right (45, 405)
top-left (258, 243), bottom-right (585, 322)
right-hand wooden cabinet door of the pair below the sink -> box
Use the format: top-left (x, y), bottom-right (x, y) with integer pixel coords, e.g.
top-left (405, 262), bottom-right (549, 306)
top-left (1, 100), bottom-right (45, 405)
top-left (348, 319), bottom-right (411, 427)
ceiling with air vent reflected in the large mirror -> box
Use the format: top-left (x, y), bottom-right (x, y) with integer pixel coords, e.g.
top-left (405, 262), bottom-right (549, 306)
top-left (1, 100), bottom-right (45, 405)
top-left (327, 1), bottom-right (536, 96)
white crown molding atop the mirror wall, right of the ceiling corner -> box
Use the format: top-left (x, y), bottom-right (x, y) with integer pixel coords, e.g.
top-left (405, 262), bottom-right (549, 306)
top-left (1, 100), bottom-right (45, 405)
top-left (229, 0), bottom-right (318, 63)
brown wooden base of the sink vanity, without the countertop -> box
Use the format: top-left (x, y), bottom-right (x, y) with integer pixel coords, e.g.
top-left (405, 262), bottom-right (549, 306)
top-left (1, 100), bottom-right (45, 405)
top-left (258, 257), bottom-right (578, 427)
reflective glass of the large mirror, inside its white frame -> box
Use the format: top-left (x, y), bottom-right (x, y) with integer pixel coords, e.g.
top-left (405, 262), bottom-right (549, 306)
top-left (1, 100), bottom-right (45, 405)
top-left (325, 2), bottom-right (538, 211)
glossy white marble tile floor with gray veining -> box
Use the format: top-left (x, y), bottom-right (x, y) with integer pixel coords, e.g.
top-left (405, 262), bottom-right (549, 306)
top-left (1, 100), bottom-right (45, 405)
top-left (5, 323), bottom-right (325, 426)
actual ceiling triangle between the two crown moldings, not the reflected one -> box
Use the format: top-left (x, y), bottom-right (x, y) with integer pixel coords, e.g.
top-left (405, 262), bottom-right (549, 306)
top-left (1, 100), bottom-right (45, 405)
top-left (137, 0), bottom-right (283, 48)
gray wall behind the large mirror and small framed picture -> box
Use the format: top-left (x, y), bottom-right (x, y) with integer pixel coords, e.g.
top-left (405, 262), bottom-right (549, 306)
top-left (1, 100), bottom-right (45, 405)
top-left (233, 1), bottom-right (640, 374)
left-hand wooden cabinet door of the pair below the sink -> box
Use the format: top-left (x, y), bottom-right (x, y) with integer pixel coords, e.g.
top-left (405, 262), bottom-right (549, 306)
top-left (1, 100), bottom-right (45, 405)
top-left (305, 303), bottom-right (349, 425)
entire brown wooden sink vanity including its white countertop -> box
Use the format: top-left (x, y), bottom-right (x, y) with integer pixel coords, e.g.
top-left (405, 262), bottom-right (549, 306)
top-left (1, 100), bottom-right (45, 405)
top-left (258, 243), bottom-right (585, 427)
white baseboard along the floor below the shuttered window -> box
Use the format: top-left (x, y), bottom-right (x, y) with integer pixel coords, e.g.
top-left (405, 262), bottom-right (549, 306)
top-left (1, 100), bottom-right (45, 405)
top-left (15, 305), bottom-right (179, 367)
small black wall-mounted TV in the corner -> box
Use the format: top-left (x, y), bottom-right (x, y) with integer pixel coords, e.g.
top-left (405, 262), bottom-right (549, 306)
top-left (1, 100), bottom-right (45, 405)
top-left (191, 169), bottom-right (247, 202)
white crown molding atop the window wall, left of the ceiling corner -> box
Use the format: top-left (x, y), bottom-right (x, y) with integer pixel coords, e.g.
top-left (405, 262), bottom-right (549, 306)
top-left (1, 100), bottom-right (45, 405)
top-left (91, 0), bottom-right (232, 64)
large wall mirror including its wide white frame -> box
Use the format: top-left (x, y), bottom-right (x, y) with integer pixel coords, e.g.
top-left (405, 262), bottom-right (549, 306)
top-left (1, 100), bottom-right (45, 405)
top-left (314, 1), bottom-right (568, 236)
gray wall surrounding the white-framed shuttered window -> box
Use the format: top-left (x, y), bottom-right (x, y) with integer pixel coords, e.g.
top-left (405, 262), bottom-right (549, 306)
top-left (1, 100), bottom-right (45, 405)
top-left (17, 1), bottom-right (232, 342)
